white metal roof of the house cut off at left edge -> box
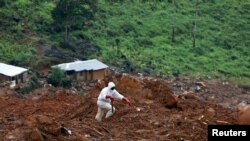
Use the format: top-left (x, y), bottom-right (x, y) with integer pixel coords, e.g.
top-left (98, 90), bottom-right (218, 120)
top-left (0, 63), bottom-right (28, 77)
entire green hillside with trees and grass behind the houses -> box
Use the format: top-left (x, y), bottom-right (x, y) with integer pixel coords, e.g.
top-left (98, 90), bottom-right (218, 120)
top-left (0, 0), bottom-right (250, 84)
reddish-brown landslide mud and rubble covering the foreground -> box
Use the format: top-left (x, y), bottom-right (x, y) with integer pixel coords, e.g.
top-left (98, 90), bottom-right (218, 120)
top-left (0, 75), bottom-right (250, 141)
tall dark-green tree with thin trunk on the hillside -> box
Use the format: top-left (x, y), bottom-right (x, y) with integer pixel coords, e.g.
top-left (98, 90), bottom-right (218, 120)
top-left (52, 0), bottom-right (97, 42)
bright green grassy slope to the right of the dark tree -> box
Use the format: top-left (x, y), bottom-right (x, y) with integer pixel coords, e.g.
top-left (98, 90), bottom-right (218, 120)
top-left (84, 0), bottom-right (250, 81)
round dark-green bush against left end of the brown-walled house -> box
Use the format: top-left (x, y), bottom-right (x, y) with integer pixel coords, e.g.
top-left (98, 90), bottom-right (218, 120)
top-left (47, 67), bottom-right (71, 88)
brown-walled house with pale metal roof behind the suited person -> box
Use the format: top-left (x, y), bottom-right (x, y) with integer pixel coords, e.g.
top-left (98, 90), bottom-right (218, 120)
top-left (52, 59), bottom-right (108, 81)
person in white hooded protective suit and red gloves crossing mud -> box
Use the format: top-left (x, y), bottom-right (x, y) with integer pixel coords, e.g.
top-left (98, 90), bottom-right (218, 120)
top-left (95, 82), bottom-right (130, 122)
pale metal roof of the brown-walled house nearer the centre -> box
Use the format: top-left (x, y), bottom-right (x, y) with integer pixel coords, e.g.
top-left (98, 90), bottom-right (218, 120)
top-left (53, 59), bottom-right (108, 72)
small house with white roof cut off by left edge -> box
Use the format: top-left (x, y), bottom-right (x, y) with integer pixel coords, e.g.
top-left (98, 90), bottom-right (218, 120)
top-left (0, 63), bottom-right (28, 87)
